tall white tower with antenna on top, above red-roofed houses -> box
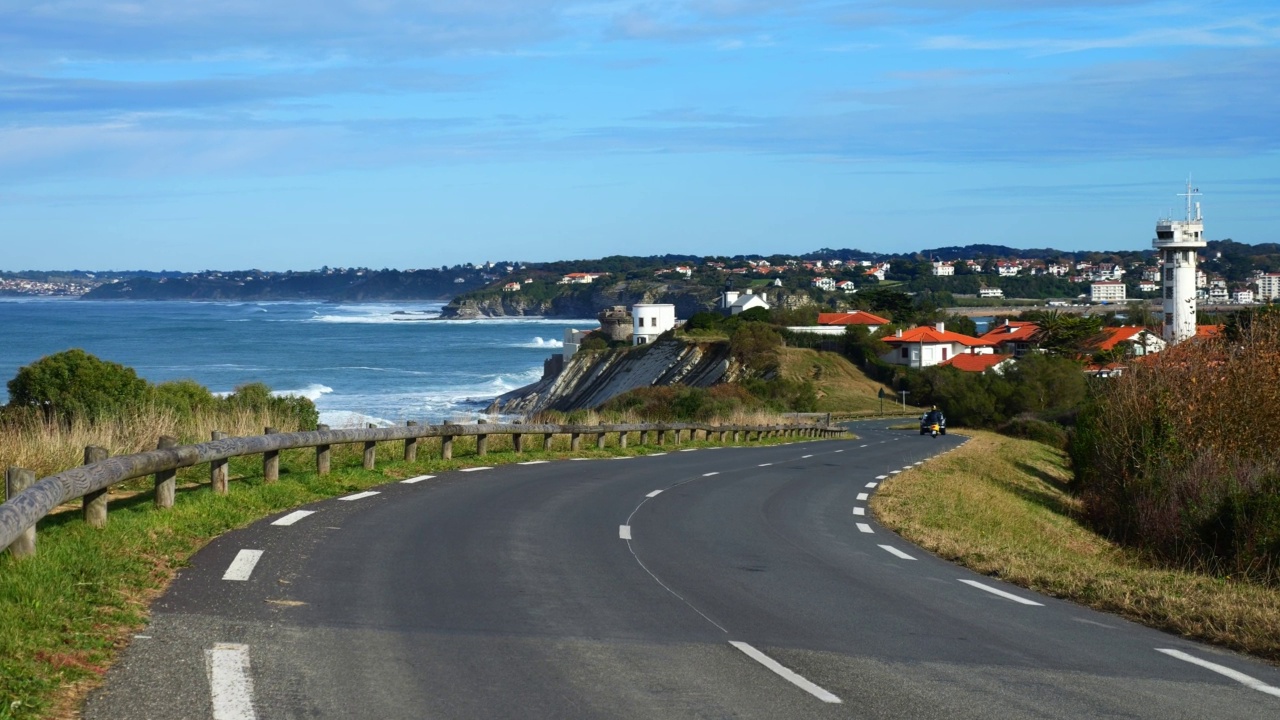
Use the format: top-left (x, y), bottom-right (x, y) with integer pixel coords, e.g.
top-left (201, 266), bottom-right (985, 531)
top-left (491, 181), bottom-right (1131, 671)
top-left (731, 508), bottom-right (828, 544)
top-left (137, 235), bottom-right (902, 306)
top-left (1152, 181), bottom-right (1206, 345)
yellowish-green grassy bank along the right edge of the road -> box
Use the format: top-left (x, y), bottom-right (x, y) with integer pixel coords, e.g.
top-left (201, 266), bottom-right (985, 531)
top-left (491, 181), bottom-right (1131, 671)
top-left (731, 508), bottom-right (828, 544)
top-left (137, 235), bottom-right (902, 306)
top-left (872, 430), bottom-right (1280, 662)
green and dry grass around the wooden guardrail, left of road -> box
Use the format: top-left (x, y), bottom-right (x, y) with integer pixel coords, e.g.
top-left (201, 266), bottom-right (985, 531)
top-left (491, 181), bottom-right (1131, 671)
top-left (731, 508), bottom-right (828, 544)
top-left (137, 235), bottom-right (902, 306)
top-left (0, 415), bottom-right (819, 719)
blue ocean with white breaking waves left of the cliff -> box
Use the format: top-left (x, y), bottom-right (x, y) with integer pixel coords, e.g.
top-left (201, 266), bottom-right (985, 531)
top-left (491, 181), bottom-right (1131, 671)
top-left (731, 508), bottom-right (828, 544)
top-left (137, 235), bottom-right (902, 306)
top-left (0, 299), bottom-right (588, 428)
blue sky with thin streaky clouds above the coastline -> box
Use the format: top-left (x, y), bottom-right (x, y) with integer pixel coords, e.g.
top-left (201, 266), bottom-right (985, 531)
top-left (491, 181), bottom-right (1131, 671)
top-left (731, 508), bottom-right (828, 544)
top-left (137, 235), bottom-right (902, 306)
top-left (0, 0), bottom-right (1280, 272)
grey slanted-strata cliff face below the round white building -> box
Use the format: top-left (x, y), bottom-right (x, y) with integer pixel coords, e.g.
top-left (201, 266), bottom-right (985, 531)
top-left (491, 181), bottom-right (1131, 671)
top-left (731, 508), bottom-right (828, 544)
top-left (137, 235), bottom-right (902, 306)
top-left (489, 340), bottom-right (740, 416)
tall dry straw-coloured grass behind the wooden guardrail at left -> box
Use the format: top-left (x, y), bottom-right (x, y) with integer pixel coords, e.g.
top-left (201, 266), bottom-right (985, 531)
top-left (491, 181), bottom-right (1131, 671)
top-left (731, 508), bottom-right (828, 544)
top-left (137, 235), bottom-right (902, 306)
top-left (0, 405), bottom-right (312, 489)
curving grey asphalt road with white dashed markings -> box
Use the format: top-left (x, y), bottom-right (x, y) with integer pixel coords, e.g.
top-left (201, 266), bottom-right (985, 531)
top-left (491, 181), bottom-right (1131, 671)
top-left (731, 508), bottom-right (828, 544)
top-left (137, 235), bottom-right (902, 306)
top-left (83, 423), bottom-right (1280, 720)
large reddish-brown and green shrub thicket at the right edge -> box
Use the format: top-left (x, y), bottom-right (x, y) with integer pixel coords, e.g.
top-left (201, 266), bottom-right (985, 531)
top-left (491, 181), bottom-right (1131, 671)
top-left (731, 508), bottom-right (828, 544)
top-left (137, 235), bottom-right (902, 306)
top-left (1071, 314), bottom-right (1280, 585)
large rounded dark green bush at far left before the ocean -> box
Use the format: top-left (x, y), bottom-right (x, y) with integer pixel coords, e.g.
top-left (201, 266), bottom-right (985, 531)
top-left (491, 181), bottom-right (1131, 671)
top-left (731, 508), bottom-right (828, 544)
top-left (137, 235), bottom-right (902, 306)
top-left (9, 348), bottom-right (151, 420)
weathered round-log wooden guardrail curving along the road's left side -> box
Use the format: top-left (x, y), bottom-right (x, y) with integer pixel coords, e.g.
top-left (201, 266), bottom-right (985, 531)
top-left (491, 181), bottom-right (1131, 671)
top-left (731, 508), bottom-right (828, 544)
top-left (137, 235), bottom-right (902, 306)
top-left (0, 421), bottom-right (846, 556)
